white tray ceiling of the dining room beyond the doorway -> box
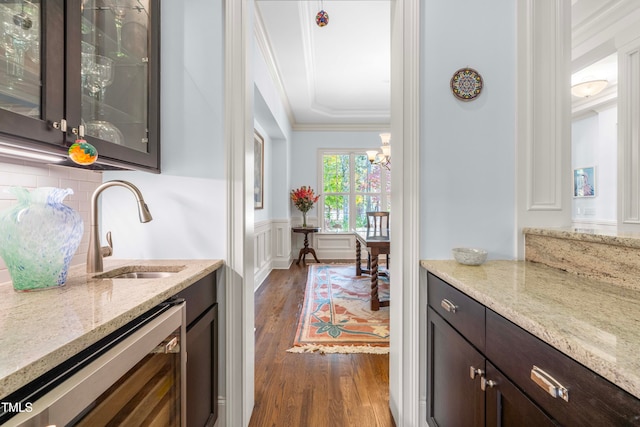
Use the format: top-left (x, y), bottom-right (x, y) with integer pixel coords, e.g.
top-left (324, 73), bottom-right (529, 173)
top-left (255, 0), bottom-right (391, 130)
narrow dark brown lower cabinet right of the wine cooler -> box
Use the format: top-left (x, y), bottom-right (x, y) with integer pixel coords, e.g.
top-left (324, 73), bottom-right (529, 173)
top-left (177, 272), bottom-right (218, 427)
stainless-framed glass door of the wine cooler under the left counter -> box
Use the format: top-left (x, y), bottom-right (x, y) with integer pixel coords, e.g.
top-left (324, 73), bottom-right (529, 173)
top-left (9, 301), bottom-right (187, 427)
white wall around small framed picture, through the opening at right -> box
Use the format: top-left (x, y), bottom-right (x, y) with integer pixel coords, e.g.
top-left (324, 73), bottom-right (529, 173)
top-left (571, 106), bottom-right (618, 226)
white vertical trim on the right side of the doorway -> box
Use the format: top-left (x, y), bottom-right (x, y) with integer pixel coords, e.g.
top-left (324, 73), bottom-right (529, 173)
top-left (389, 0), bottom-right (420, 426)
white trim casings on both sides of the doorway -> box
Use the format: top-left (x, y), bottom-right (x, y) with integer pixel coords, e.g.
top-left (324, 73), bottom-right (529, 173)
top-left (225, 0), bottom-right (420, 425)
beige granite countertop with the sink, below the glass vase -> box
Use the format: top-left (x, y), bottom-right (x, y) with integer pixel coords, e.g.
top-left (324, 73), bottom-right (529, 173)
top-left (0, 258), bottom-right (223, 400)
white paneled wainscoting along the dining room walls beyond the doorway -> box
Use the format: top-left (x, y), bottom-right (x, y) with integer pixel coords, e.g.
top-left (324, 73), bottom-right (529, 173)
top-left (254, 219), bottom-right (364, 290)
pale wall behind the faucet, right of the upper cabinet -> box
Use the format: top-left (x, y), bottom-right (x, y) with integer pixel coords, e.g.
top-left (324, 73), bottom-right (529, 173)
top-left (101, 0), bottom-right (227, 259)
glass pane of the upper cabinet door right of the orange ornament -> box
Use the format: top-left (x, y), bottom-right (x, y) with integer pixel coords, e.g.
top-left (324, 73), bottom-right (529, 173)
top-left (75, 0), bottom-right (157, 165)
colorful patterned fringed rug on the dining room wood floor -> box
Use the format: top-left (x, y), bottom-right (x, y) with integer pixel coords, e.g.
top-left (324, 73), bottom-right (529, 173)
top-left (287, 264), bottom-right (389, 354)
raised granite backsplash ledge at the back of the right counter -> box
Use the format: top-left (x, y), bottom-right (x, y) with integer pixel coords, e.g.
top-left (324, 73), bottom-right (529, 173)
top-left (523, 228), bottom-right (640, 290)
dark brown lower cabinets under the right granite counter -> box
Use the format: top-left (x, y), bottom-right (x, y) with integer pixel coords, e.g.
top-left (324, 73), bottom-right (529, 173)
top-left (426, 273), bottom-right (640, 427)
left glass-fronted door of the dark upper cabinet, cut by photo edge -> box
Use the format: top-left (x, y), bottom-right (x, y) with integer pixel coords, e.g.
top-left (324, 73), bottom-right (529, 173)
top-left (0, 0), bottom-right (64, 145)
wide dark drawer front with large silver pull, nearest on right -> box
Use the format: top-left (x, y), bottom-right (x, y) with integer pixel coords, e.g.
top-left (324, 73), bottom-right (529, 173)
top-left (485, 309), bottom-right (640, 426)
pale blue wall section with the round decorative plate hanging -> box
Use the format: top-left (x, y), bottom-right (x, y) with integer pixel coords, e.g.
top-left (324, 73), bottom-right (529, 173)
top-left (420, 0), bottom-right (517, 259)
